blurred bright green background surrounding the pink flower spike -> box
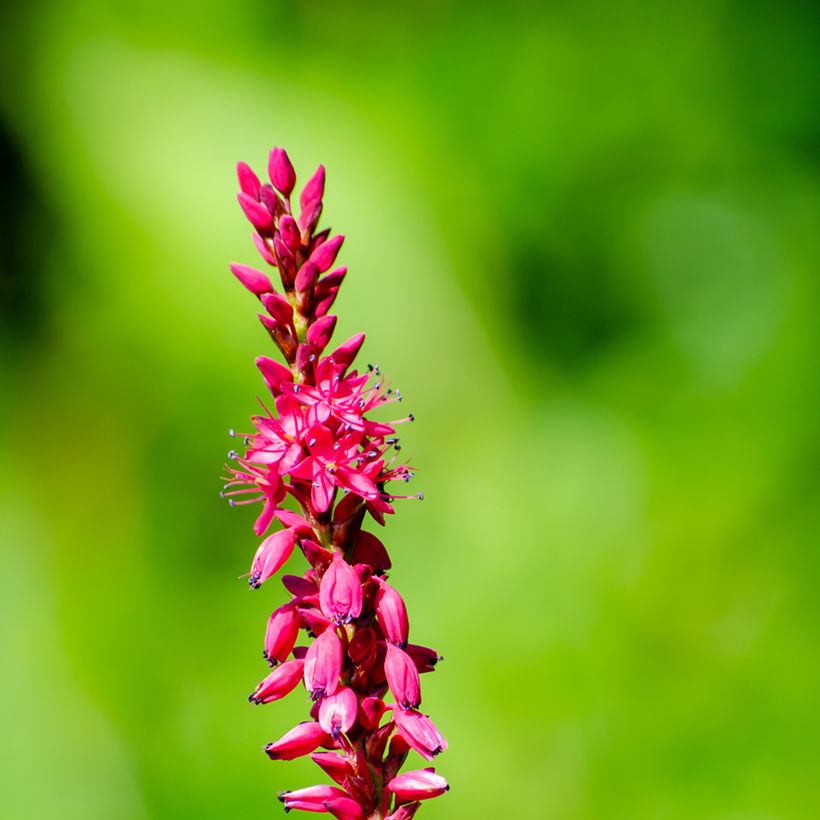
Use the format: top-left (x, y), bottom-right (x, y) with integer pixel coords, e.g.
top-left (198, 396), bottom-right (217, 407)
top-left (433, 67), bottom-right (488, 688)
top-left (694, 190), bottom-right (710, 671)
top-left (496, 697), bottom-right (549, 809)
top-left (0, 0), bottom-right (820, 820)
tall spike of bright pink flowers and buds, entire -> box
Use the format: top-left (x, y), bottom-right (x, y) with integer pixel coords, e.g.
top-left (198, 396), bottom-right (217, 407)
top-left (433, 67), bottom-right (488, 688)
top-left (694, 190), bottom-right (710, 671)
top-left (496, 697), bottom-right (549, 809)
top-left (222, 148), bottom-right (449, 820)
